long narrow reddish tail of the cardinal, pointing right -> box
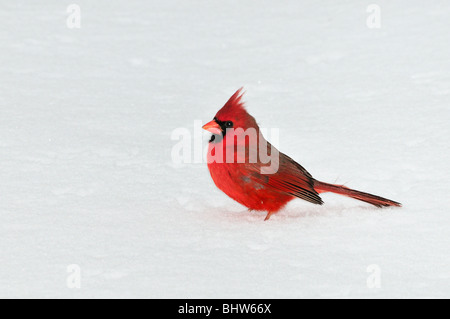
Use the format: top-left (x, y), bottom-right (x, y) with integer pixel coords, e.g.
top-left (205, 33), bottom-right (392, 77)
top-left (314, 181), bottom-right (402, 207)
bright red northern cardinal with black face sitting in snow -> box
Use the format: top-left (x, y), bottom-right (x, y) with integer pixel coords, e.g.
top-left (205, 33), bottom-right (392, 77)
top-left (203, 88), bottom-right (401, 220)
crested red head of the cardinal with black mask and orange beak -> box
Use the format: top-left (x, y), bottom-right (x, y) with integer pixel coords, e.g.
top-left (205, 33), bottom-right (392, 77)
top-left (203, 88), bottom-right (259, 142)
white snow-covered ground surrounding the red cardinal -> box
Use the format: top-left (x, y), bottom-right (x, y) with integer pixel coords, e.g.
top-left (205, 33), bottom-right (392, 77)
top-left (0, 0), bottom-right (450, 298)
